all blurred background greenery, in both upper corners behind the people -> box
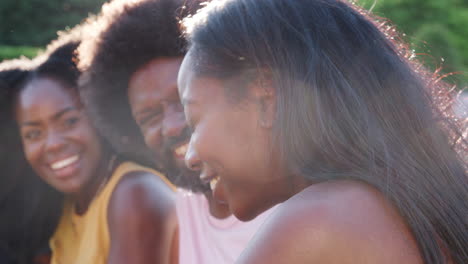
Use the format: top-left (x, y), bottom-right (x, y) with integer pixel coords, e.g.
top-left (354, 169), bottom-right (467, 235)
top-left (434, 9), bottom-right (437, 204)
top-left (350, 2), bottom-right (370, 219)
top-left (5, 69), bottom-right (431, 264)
top-left (0, 0), bottom-right (468, 89)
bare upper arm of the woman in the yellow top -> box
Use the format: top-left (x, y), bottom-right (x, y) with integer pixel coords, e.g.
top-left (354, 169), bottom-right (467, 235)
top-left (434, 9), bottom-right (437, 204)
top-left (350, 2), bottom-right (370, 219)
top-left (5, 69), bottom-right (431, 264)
top-left (108, 172), bottom-right (177, 264)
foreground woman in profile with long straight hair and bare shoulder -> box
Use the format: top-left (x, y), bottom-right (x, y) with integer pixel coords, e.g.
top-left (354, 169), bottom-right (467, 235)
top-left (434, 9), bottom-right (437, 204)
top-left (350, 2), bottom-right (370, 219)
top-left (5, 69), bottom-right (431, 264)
top-left (179, 0), bottom-right (468, 263)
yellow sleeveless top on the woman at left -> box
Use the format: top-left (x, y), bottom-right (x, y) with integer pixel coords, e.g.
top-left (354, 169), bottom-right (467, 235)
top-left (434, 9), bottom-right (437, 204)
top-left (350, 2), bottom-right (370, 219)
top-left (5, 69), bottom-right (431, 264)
top-left (50, 162), bottom-right (175, 264)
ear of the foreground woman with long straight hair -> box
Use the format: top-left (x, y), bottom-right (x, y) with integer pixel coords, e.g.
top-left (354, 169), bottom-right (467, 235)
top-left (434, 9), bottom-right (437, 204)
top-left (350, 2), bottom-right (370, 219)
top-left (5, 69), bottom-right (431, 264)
top-left (249, 74), bottom-right (276, 128)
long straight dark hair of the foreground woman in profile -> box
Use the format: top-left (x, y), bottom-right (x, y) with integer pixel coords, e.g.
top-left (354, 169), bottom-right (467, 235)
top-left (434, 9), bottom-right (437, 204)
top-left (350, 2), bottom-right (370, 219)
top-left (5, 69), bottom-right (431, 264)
top-left (183, 0), bottom-right (468, 263)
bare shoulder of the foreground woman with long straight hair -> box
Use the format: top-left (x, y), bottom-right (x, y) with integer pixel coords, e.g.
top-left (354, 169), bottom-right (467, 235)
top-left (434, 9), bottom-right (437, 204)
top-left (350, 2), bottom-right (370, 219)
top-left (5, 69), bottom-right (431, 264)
top-left (238, 181), bottom-right (422, 264)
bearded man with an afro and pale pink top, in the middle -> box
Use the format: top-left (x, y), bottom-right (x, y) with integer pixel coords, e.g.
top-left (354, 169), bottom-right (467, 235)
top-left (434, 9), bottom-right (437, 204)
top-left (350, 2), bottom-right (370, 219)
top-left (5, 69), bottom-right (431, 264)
top-left (78, 0), bottom-right (269, 264)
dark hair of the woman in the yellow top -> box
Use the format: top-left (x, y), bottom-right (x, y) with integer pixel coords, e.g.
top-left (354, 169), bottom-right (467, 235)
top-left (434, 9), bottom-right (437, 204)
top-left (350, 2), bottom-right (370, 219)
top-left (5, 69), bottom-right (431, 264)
top-left (0, 27), bottom-right (89, 264)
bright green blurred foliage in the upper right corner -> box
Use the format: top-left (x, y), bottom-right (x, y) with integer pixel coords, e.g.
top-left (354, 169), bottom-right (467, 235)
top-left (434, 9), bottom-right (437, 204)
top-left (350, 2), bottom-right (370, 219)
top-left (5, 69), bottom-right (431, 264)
top-left (357, 0), bottom-right (468, 87)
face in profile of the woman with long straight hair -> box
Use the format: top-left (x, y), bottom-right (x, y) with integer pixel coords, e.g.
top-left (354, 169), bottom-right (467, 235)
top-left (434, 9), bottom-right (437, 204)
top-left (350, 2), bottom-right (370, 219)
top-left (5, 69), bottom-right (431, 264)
top-left (179, 55), bottom-right (288, 220)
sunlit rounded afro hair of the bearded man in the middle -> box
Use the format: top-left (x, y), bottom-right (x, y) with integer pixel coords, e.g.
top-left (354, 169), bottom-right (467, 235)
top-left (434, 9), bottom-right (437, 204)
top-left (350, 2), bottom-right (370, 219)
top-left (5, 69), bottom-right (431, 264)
top-left (78, 0), bottom-right (198, 169)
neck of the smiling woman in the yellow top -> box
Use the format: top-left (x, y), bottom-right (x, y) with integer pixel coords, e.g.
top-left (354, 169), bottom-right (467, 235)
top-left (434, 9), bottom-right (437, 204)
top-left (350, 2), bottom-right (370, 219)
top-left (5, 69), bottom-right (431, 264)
top-left (72, 153), bottom-right (116, 214)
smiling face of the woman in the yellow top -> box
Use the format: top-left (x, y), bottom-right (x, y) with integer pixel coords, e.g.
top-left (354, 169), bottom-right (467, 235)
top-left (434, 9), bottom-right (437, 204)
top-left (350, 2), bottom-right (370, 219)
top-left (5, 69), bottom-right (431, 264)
top-left (15, 77), bottom-right (106, 194)
